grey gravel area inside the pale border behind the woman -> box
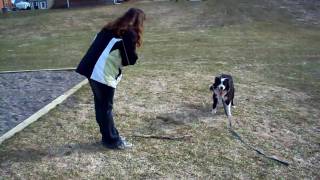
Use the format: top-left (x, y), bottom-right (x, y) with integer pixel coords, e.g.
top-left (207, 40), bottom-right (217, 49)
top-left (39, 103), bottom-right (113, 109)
top-left (0, 71), bottom-right (84, 136)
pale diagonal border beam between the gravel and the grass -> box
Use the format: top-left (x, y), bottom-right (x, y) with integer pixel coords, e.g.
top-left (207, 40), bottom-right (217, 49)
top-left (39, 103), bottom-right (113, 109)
top-left (0, 79), bottom-right (88, 144)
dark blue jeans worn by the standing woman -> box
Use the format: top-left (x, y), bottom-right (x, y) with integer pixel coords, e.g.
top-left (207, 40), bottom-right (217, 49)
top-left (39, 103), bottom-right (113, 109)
top-left (89, 79), bottom-right (120, 146)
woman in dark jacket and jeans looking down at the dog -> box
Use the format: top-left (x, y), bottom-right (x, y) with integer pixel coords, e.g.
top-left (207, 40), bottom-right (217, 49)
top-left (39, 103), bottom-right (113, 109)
top-left (76, 8), bottom-right (145, 149)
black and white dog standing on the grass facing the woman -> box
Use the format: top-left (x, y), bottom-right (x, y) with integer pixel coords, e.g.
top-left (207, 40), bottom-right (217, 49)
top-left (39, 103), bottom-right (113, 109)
top-left (210, 74), bottom-right (234, 117)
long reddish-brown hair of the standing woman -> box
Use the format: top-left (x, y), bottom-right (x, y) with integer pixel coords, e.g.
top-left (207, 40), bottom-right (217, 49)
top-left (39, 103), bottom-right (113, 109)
top-left (104, 8), bottom-right (146, 47)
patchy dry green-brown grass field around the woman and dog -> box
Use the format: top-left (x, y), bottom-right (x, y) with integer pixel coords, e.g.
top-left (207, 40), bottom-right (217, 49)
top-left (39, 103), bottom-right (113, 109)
top-left (0, 0), bottom-right (320, 179)
